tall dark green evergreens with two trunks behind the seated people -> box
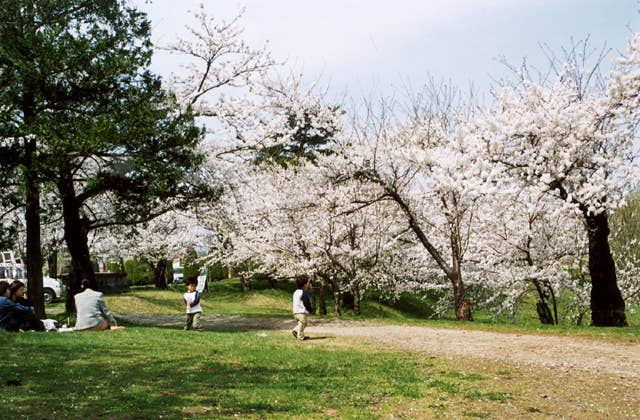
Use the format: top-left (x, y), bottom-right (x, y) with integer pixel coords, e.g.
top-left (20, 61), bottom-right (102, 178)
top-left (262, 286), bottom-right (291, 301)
top-left (0, 0), bottom-right (215, 309)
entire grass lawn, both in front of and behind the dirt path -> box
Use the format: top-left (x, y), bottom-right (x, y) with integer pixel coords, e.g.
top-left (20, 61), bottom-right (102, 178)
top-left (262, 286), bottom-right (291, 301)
top-left (0, 281), bottom-right (640, 419)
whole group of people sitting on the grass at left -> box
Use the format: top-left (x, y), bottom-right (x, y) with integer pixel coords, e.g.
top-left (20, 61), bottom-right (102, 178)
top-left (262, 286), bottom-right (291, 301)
top-left (0, 279), bottom-right (124, 332)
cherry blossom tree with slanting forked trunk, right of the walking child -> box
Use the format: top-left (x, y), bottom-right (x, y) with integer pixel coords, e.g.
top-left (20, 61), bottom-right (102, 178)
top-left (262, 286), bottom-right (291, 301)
top-left (324, 85), bottom-right (484, 320)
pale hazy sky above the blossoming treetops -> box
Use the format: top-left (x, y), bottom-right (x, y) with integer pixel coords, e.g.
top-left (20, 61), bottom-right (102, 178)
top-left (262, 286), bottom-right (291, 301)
top-left (133, 0), bottom-right (640, 97)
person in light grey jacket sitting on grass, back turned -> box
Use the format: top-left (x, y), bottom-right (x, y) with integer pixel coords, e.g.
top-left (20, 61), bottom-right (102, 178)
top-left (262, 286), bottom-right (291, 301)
top-left (73, 279), bottom-right (124, 331)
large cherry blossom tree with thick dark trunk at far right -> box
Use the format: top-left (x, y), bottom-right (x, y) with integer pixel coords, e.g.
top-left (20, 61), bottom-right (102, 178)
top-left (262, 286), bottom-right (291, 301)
top-left (474, 38), bottom-right (638, 326)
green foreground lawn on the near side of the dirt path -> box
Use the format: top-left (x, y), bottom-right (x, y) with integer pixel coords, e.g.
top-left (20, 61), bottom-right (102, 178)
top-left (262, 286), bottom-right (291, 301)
top-left (0, 327), bottom-right (508, 418)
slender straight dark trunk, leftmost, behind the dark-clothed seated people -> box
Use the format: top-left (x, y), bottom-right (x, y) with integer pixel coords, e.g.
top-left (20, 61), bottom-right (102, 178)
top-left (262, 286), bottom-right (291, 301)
top-left (25, 140), bottom-right (46, 319)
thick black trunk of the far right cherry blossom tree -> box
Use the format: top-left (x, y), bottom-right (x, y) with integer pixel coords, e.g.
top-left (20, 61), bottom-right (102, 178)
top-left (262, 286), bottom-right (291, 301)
top-left (585, 212), bottom-right (629, 327)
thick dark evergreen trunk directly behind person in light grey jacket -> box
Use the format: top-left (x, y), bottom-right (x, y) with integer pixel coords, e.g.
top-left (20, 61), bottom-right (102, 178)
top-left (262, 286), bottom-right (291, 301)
top-left (58, 175), bottom-right (96, 312)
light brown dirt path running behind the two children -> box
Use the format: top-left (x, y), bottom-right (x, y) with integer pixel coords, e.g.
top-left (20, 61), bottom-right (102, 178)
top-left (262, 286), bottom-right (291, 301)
top-left (115, 314), bottom-right (640, 379)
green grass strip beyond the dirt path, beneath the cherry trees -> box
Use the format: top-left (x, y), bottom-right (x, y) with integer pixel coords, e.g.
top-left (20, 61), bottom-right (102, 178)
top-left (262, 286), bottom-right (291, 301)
top-left (47, 279), bottom-right (640, 342)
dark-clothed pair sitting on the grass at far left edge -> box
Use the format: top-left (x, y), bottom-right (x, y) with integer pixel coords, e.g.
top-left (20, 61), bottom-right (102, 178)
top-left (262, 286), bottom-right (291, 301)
top-left (0, 281), bottom-right (45, 332)
